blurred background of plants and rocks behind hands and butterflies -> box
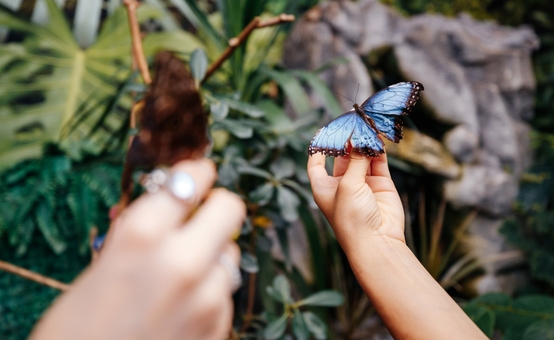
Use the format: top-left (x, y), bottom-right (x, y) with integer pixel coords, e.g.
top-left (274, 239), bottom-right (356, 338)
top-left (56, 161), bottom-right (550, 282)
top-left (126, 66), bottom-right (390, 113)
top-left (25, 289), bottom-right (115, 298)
top-left (0, 0), bottom-right (554, 339)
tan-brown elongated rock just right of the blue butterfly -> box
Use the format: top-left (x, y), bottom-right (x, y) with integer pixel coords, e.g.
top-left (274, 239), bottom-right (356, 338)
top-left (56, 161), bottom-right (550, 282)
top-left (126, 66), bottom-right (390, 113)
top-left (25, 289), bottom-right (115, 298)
top-left (385, 128), bottom-right (460, 178)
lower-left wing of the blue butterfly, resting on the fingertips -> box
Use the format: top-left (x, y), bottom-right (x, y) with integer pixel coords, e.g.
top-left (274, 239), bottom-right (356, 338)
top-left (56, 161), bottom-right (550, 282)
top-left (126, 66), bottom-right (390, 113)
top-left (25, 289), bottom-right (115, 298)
top-left (308, 111), bottom-right (383, 157)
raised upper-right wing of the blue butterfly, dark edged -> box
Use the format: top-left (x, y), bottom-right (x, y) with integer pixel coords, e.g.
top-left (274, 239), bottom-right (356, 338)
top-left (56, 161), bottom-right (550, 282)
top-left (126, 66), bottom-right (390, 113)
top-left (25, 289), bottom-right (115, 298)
top-left (360, 81), bottom-right (423, 143)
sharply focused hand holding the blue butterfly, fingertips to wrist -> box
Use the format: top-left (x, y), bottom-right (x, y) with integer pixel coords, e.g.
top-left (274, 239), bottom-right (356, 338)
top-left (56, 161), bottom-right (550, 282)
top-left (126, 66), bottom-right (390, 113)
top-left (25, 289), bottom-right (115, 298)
top-left (308, 150), bottom-right (405, 251)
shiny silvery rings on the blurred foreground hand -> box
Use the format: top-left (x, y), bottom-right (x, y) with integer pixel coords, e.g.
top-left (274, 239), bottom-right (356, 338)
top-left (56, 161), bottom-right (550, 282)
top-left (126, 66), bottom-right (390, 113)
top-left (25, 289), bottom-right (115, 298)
top-left (140, 168), bottom-right (196, 201)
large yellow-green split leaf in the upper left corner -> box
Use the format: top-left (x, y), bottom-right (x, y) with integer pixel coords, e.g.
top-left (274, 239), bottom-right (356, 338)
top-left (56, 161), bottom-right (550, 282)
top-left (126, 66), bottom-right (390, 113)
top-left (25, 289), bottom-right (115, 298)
top-left (0, 0), bottom-right (199, 167)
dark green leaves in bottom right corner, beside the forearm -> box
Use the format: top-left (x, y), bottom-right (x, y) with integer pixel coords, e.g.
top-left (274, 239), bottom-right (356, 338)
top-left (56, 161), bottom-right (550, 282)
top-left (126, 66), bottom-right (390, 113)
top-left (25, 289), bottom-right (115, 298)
top-left (464, 293), bottom-right (554, 340)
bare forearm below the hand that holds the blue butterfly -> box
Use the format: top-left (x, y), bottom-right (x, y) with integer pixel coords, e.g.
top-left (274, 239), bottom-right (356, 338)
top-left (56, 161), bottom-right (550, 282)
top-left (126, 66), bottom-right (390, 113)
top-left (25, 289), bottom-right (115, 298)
top-left (347, 236), bottom-right (487, 340)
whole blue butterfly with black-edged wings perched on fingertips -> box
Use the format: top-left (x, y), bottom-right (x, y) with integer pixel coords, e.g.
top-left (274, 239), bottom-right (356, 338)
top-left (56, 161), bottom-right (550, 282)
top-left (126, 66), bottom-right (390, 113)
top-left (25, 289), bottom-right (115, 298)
top-left (308, 81), bottom-right (423, 157)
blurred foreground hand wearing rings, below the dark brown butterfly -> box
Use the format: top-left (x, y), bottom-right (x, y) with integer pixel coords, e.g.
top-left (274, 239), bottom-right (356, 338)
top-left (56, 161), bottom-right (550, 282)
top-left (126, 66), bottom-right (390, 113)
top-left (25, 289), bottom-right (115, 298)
top-left (33, 159), bottom-right (245, 339)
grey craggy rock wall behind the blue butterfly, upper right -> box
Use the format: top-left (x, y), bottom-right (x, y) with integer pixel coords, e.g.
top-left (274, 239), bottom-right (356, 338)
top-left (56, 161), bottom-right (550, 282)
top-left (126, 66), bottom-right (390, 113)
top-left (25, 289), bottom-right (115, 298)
top-left (284, 0), bottom-right (539, 292)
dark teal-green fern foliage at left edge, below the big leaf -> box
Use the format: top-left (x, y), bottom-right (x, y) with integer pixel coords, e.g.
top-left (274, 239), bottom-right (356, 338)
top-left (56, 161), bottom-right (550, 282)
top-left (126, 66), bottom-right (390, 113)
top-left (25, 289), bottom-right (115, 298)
top-left (0, 146), bottom-right (122, 255)
